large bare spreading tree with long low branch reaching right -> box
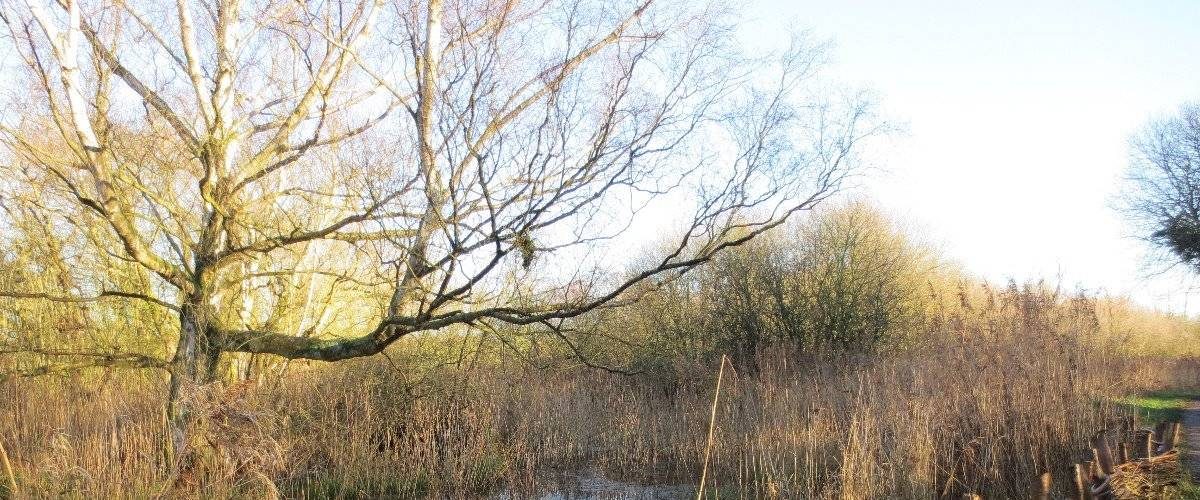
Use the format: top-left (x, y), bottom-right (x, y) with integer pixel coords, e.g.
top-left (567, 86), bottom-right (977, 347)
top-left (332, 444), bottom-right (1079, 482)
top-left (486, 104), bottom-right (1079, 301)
top-left (0, 0), bottom-right (880, 455)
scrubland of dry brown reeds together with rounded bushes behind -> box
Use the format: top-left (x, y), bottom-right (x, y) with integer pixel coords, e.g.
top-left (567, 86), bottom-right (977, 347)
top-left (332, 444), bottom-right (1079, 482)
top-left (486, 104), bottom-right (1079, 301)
top-left (0, 203), bottom-right (1200, 499)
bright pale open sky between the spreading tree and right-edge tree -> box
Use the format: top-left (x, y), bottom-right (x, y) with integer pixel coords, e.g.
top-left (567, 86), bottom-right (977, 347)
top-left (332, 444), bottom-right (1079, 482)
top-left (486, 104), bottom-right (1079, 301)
top-left (748, 0), bottom-right (1200, 313)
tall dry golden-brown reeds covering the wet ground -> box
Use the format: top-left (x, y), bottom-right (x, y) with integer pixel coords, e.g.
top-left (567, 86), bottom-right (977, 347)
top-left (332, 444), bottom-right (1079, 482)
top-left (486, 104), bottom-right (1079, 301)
top-left (0, 282), bottom-right (1196, 498)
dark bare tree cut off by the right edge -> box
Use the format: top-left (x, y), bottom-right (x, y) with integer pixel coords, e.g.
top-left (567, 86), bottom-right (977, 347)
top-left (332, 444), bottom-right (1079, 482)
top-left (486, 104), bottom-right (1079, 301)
top-left (1123, 104), bottom-right (1200, 270)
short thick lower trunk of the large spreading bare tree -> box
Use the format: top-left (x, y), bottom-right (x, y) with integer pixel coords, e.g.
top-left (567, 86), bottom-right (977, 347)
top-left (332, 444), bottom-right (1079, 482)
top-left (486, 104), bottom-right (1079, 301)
top-left (167, 301), bottom-right (221, 468)
